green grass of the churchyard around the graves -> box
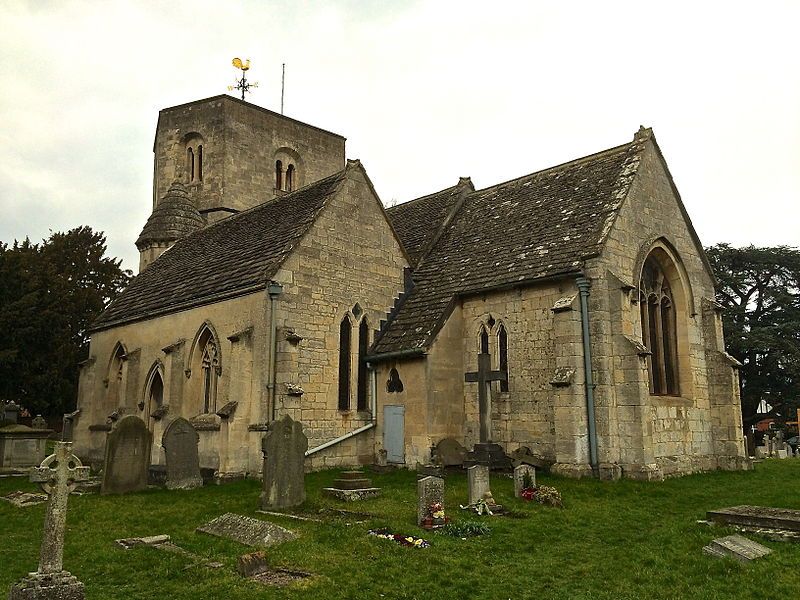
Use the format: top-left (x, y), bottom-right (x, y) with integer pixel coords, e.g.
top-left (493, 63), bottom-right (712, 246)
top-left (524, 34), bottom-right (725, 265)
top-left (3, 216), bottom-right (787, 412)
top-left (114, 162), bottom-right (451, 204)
top-left (0, 460), bottom-right (800, 600)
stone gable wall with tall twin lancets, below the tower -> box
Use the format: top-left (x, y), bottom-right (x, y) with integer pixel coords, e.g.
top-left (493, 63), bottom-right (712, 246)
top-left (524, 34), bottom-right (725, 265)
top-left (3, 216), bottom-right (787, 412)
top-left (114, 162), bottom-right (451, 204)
top-left (268, 168), bottom-right (408, 468)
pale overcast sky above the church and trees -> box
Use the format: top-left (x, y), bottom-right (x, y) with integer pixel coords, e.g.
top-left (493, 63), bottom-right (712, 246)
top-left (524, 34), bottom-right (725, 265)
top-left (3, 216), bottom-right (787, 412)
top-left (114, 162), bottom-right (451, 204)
top-left (0, 0), bottom-right (800, 272)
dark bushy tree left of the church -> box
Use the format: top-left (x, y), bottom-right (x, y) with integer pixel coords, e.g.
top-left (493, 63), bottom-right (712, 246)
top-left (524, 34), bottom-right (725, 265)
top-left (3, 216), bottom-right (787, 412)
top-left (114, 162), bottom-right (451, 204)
top-left (0, 226), bottom-right (131, 415)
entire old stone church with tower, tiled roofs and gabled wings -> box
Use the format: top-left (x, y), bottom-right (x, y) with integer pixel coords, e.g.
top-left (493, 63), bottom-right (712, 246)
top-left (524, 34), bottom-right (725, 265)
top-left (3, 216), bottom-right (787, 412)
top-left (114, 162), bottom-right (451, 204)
top-left (73, 96), bottom-right (748, 479)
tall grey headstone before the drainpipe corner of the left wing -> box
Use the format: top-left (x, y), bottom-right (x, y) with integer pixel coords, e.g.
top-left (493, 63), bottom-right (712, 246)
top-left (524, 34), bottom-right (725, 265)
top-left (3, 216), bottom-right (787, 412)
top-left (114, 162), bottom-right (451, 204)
top-left (261, 415), bottom-right (308, 509)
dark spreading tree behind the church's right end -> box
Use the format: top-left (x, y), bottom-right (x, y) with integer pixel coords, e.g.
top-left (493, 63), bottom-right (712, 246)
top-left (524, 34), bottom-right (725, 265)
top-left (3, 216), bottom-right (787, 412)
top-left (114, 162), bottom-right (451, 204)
top-left (706, 244), bottom-right (800, 429)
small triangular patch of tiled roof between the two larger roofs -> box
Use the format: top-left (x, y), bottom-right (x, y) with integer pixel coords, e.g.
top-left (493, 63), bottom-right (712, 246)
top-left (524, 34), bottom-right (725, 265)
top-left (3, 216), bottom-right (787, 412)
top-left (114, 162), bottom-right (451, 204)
top-left (386, 178), bottom-right (475, 265)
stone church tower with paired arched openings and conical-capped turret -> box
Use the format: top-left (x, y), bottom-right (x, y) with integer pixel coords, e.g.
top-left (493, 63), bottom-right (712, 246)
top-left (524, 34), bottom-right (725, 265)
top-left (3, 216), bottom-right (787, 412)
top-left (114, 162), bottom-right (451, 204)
top-left (136, 95), bottom-right (345, 272)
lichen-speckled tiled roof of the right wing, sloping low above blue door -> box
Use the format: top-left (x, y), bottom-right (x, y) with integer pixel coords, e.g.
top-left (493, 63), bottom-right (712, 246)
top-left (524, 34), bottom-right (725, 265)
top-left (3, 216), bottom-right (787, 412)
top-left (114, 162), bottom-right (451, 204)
top-left (371, 130), bottom-right (649, 355)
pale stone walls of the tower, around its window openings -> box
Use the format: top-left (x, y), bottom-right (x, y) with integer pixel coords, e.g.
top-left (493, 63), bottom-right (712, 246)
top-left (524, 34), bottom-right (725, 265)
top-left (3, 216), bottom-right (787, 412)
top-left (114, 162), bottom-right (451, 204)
top-left (153, 96), bottom-right (345, 222)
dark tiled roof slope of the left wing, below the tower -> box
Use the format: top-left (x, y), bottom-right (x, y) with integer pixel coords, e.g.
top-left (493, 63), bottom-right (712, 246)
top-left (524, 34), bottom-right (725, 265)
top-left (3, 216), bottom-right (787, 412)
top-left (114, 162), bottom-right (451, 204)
top-left (92, 163), bottom-right (348, 329)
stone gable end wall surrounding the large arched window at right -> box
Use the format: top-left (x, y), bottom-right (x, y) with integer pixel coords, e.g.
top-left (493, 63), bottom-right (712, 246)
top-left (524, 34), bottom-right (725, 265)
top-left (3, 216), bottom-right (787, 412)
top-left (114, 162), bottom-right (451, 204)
top-left (586, 137), bottom-right (744, 478)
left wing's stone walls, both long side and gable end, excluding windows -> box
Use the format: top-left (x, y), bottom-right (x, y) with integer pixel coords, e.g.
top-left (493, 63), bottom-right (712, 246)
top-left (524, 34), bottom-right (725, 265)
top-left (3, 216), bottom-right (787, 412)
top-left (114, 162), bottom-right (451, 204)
top-left (75, 168), bottom-right (408, 475)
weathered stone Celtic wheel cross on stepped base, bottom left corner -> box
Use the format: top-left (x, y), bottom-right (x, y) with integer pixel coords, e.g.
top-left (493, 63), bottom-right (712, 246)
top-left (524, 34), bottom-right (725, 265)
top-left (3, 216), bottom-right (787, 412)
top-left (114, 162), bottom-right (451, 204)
top-left (8, 442), bottom-right (89, 600)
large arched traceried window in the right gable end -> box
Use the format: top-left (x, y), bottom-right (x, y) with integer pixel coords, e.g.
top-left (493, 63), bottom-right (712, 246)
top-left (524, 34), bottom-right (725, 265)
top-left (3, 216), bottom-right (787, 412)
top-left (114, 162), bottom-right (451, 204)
top-left (639, 256), bottom-right (680, 396)
